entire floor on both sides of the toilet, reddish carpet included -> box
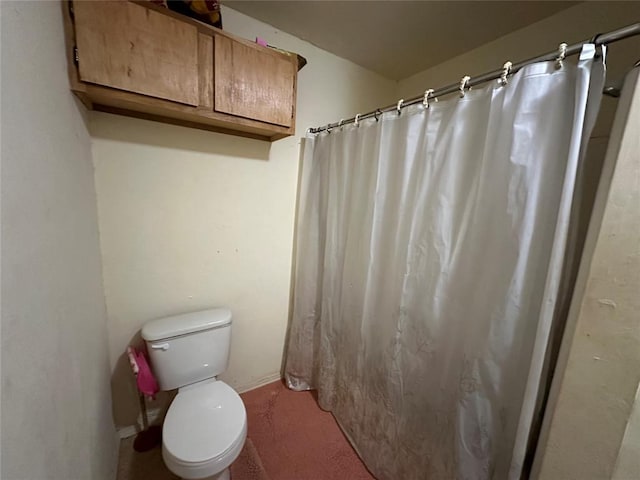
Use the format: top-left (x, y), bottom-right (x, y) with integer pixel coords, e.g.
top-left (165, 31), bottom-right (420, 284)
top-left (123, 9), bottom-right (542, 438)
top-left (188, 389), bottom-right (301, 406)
top-left (117, 381), bottom-right (375, 480)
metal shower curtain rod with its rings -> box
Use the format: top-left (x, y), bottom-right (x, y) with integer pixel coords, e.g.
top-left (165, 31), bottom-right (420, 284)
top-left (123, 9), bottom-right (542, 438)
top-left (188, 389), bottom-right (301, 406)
top-left (308, 22), bottom-right (640, 133)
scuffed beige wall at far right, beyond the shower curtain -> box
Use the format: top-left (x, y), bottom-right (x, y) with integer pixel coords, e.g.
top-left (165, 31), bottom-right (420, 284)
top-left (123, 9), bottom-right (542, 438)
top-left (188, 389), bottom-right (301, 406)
top-left (534, 69), bottom-right (640, 480)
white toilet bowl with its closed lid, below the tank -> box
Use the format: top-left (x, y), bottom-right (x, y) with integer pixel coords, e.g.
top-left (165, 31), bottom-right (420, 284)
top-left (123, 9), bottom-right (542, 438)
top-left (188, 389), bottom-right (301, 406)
top-left (162, 381), bottom-right (247, 479)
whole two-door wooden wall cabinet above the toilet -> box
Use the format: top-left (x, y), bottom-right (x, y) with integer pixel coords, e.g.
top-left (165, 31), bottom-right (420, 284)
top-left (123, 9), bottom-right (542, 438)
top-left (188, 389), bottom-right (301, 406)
top-left (62, 0), bottom-right (298, 141)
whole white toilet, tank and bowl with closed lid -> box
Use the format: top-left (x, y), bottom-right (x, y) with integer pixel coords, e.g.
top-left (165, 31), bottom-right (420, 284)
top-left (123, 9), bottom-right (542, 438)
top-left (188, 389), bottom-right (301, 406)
top-left (142, 308), bottom-right (247, 480)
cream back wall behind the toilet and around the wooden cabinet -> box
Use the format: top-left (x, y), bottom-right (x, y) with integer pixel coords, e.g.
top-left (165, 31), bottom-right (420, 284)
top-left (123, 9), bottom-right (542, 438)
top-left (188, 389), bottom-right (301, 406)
top-left (90, 8), bottom-right (396, 426)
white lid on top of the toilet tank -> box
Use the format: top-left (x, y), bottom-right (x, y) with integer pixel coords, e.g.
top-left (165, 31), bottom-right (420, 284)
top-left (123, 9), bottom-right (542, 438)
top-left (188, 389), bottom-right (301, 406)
top-left (142, 308), bottom-right (231, 341)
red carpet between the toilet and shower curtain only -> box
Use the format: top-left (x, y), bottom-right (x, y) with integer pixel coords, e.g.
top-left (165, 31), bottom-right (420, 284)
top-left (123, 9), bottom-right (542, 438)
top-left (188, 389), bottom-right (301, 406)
top-left (242, 381), bottom-right (375, 480)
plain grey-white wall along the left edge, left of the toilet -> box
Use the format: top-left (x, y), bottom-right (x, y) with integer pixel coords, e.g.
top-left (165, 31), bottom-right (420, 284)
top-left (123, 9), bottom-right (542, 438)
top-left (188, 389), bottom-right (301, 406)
top-left (0, 2), bottom-right (117, 480)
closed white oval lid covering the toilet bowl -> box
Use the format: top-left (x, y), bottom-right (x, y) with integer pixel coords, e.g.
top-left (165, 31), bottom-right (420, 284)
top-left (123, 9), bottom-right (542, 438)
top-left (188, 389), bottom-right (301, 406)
top-left (162, 381), bottom-right (247, 463)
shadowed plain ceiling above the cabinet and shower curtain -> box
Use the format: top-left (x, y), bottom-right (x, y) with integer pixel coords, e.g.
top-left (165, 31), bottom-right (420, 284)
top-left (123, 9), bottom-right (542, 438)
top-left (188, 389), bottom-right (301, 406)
top-left (223, 0), bottom-right (579, 80)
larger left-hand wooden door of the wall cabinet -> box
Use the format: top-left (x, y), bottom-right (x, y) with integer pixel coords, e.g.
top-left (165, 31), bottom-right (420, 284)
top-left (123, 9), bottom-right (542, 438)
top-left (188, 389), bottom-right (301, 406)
top-left (73, 1), bottom-right (199, 105)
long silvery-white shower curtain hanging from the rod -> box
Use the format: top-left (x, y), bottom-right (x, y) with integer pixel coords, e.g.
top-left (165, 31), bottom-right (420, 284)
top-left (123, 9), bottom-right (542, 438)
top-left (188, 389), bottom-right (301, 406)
top-left (285, 45), bottom-right (603, 480)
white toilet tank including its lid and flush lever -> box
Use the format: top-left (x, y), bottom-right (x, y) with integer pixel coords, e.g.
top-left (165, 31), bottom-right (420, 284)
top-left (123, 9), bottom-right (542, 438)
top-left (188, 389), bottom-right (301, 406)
top-left (142, 308), bottom-right (231, 390)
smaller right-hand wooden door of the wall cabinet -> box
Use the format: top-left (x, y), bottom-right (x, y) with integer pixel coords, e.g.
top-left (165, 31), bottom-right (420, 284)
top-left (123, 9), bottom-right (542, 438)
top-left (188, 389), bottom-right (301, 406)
top-left (214, 35), bottom-right (296, 127)
